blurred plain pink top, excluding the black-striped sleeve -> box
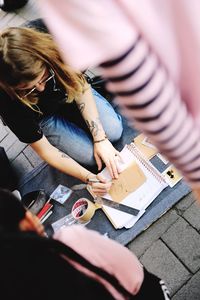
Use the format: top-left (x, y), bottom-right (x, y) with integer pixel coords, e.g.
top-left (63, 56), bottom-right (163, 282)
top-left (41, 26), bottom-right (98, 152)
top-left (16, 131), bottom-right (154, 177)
top-left (40, 0), bottom-right (200, 119)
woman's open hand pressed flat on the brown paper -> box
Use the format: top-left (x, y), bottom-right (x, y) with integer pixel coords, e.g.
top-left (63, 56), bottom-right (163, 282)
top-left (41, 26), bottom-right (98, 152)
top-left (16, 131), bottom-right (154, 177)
top-left (94, 139), bottom-right (121, 178)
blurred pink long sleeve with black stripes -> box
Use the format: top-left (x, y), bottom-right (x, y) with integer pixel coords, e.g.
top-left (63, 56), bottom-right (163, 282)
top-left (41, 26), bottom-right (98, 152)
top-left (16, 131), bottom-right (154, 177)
top-left (100, 35), bottom-right (200, 187)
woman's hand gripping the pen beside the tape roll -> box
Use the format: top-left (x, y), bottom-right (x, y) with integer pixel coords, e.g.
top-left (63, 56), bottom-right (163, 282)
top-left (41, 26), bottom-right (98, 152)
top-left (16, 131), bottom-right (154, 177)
top-left (88, 173), bottom-right (112, 196)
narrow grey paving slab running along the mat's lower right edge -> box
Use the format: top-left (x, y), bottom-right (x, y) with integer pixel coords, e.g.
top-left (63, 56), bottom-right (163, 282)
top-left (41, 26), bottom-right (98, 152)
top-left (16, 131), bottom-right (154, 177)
top-left (128, 209), bottom-right (178, 257)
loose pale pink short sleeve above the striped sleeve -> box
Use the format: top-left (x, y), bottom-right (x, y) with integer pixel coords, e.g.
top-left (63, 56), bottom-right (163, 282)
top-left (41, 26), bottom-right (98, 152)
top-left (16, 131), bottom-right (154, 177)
top-left (39, 0), bottom-right (135, 69)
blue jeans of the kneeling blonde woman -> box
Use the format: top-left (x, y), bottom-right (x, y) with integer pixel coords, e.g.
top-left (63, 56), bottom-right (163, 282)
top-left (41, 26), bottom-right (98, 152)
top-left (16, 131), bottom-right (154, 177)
top-left (41, 89), bottom-right (123, 166)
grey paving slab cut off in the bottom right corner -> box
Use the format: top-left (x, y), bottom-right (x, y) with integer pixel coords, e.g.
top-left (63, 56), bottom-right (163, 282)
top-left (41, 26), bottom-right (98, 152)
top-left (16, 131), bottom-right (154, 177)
top-left (172, 271), bottom-right (200, 300)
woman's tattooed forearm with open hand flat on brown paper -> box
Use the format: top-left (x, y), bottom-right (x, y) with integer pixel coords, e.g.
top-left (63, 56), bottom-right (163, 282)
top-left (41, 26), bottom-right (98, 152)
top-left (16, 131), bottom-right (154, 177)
top-left (75, 85), bottom-right (119, 178)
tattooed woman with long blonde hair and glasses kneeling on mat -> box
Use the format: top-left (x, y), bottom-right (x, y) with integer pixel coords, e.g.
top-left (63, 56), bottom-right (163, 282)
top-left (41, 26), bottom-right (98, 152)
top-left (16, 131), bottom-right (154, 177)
top-left (0, 27), bottom-right (123, 194)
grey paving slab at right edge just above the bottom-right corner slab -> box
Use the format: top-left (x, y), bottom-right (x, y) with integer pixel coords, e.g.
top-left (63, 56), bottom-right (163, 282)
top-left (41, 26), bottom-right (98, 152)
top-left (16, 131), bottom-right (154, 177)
top-left (161, 217), bottom-right (200, 273)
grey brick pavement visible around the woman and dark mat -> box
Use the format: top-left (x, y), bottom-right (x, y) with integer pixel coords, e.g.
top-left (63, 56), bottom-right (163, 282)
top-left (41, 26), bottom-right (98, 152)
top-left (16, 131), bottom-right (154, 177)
top-left (0, 0), bottom-right (200, 300)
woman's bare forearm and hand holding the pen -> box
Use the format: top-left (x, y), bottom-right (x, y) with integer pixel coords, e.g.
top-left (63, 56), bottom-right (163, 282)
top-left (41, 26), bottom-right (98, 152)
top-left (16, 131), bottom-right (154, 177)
top-left (31, 136), bottom-right (111, 195)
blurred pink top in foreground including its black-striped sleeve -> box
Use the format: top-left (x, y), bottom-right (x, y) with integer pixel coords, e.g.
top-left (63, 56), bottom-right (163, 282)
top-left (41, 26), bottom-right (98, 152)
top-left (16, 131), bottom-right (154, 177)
top-left (40, 0), bottom-right (200, 187)
